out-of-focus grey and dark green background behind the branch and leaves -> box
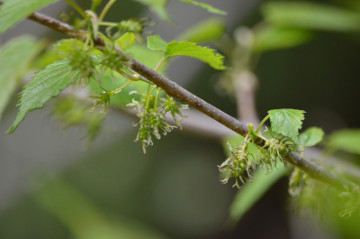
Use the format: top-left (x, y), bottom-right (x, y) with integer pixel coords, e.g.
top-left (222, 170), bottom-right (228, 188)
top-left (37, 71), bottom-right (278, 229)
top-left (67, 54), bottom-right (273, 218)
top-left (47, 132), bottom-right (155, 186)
top-left (0, 0), bottom-right (360, 239)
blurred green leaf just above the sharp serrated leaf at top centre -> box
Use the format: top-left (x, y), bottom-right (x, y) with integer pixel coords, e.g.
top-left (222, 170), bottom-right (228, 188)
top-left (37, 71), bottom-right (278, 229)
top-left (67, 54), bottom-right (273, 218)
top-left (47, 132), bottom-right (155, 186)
top-left (177, 18), bottom-right (226, 43)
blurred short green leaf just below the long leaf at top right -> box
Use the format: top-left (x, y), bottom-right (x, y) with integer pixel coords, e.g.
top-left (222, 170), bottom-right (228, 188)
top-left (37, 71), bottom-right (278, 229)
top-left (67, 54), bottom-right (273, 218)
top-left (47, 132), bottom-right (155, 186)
top-left (253, 26), bottom-right (312, 52)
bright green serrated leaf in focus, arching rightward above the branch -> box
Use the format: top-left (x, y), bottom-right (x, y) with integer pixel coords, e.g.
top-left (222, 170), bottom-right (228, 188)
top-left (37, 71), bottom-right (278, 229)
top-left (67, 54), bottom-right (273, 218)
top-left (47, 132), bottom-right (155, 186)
top-left (165, 41), bottom-right (225, 70)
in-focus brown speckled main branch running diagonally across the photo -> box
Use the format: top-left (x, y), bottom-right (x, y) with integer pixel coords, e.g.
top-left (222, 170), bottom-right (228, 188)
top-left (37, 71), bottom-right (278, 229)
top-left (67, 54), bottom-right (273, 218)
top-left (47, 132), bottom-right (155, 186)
top-left (29, 13), bottom-right (360, 193)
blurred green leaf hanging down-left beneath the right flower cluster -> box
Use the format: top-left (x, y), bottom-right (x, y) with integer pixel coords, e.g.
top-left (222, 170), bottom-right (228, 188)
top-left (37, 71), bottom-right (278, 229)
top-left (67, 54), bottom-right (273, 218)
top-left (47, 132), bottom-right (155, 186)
top-left (230, 164), bottom-right (288, 222)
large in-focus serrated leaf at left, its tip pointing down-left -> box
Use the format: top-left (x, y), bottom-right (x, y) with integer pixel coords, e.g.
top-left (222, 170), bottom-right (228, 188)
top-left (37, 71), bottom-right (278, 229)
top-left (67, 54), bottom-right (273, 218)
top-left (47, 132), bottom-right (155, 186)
top-left (7, 59), bottom-right (80, 134)
